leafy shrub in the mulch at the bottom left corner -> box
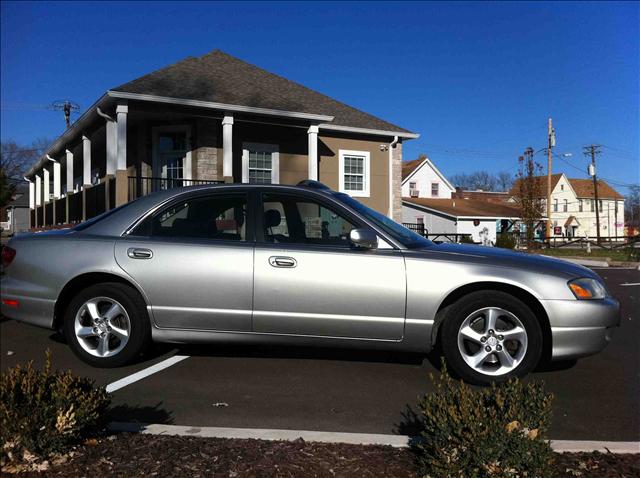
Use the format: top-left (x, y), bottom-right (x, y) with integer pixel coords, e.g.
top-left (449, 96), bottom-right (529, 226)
top-left (0, 351), bottom-right (111, 462)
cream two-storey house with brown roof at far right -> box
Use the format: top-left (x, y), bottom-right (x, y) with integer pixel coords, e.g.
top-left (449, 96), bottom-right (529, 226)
top-left (510, 173), bottom-right (624, 237)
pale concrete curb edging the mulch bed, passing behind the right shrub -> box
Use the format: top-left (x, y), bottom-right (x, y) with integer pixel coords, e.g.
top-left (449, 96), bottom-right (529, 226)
top-left (108, 422), bottom-right (640, 453)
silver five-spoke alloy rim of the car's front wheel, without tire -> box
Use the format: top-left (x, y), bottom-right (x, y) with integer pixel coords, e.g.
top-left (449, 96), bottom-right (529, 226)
top-left (458, 307), bottom-right (528, 376)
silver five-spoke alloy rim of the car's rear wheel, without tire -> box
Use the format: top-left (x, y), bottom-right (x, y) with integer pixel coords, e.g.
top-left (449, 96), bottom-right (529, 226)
top-left (74, 297), bottom-right (131, 358)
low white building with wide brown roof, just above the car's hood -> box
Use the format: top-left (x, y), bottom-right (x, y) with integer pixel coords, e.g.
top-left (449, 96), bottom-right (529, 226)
top-left (402, 198), bottom-right (519, 246)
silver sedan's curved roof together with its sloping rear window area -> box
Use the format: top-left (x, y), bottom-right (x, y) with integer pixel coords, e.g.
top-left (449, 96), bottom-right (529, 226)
top-left (78, 181), bottom-right (337, 236)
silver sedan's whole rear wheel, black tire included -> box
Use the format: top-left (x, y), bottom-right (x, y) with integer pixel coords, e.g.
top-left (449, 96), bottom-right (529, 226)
top-left (63, 282), bottom-right (151, 368)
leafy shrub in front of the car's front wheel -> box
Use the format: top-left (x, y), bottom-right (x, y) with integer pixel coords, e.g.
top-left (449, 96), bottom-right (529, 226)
top-left (414, 367), bottom-right (554, 478)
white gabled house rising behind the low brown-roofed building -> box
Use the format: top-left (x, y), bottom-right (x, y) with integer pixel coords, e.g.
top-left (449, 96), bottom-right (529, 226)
top-left (402, 157), bottom-right (456, 199)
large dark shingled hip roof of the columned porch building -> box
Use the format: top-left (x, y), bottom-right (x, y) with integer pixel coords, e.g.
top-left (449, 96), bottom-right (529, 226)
top-left (111, 50), bottom-right (412, 134)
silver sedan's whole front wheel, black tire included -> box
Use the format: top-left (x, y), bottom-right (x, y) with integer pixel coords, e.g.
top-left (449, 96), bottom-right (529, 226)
top-left (440, 291), bottom-right (543, 385)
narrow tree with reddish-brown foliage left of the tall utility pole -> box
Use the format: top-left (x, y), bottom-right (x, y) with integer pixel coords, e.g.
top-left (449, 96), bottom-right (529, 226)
top-left (515, 148), bottom-right (545, 248)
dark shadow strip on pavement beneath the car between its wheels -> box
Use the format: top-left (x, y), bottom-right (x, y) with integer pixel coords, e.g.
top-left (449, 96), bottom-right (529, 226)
top-left (172, 344), bottom-right (424, 365)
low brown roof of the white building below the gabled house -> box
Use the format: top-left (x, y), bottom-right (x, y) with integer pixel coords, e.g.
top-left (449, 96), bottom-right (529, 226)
top-left (402, 198), bottom-right (520, 218)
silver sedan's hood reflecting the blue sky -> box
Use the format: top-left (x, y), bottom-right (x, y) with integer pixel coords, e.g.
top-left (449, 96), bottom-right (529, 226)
top-left (411, 243), bottom-right (600, 279)
